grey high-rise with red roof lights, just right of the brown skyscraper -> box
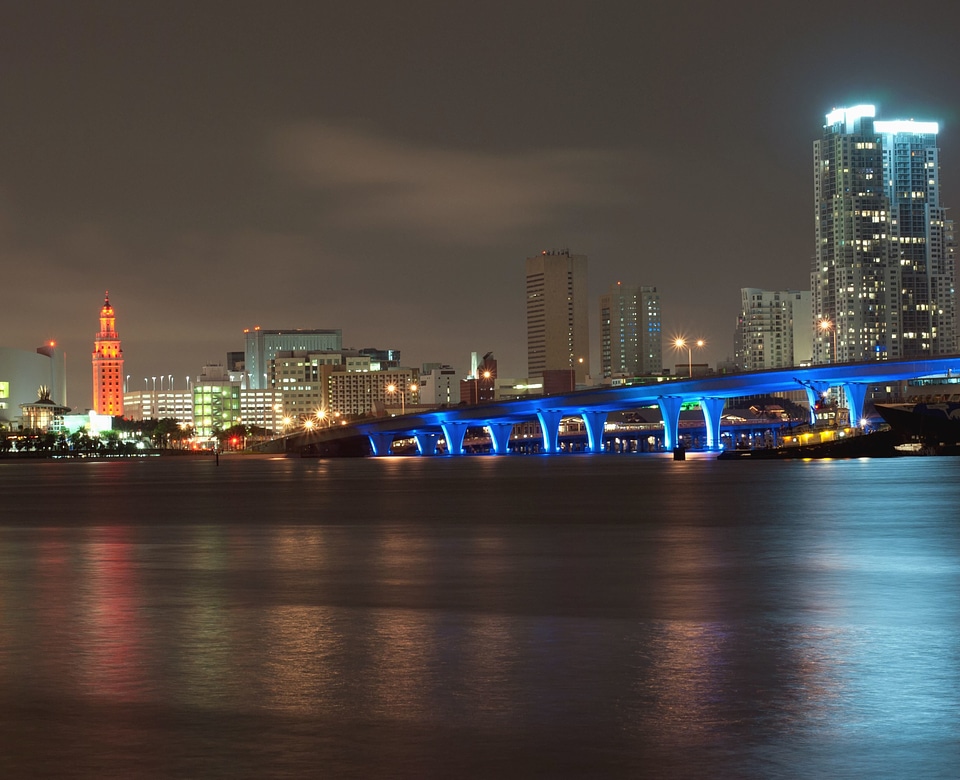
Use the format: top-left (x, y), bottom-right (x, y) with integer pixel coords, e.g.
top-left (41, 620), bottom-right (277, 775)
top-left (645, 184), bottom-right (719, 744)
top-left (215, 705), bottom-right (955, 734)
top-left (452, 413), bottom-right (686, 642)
top-left (600, 282), bottom-right (663, 377)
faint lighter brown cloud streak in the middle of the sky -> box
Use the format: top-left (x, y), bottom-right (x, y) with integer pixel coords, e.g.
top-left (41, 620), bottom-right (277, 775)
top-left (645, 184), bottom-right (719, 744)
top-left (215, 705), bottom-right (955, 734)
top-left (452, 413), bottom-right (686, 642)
top-left (276, 123), bottom-right (629, 246)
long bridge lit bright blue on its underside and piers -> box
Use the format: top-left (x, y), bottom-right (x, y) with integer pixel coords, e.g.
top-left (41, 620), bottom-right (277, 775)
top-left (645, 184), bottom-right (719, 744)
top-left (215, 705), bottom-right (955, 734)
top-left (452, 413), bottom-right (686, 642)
top-left (287, 355), bottom-right (960, 455)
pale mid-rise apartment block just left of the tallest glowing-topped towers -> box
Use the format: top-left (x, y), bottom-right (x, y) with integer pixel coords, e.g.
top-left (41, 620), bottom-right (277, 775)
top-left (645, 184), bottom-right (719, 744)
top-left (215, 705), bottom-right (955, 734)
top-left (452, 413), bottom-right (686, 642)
top-left (735, 287), bottom-right (813, 371)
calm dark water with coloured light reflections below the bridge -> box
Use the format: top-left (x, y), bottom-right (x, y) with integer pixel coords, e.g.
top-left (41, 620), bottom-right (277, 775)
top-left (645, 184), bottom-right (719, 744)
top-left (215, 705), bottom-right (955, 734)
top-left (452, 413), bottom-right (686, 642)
top-left (0, 455), bottom-right (960, 778)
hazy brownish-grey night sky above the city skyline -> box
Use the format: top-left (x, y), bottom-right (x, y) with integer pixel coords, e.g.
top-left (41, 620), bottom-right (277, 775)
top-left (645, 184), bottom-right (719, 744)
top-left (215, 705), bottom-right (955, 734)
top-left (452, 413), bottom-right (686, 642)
top-left (0, 0), bottom-right (960, 408)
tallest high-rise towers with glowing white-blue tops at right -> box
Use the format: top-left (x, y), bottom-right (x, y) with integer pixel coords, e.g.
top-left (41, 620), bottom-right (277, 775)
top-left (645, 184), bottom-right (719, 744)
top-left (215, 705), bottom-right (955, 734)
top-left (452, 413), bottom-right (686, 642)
top-left (811, 105), bottom-right (956, 363)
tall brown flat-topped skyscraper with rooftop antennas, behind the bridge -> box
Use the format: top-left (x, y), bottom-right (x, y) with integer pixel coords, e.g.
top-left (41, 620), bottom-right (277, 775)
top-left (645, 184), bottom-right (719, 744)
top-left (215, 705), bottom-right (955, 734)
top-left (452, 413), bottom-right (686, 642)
top-left (527, 249), bottom-right (590, 383)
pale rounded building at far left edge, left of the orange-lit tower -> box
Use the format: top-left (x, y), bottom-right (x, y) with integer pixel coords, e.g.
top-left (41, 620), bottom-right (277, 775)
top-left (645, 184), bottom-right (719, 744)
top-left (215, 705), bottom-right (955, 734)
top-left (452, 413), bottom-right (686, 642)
top-left (0, 342), bottom-right (67, 430)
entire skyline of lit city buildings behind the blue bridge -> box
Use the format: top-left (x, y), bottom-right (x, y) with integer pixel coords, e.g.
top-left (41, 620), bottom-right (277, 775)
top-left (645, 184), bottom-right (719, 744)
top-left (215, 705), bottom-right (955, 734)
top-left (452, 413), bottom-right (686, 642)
top-left (0, 105), bottom-right (958, 437)
